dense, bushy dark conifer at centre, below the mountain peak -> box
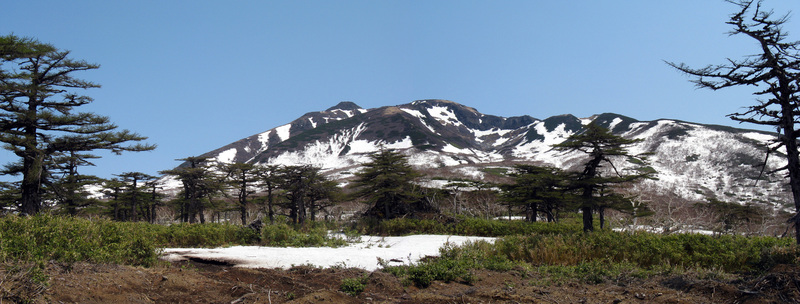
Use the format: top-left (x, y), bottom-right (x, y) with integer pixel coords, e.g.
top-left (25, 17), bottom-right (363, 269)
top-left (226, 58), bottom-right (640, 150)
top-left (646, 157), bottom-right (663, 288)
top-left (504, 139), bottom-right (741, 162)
top-left (353, 150), bottom-right (424, 219)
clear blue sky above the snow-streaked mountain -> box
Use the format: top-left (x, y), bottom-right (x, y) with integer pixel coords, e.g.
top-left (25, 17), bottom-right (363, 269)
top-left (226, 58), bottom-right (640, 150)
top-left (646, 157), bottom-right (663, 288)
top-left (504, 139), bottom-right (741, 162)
top-left (0, 0), bottom-right (800, 177)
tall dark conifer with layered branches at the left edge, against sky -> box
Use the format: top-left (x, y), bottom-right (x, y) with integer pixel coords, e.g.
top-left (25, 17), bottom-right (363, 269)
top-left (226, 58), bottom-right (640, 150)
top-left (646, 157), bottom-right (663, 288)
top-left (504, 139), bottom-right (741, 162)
top-left (0, 35), bottom-right (155, 215)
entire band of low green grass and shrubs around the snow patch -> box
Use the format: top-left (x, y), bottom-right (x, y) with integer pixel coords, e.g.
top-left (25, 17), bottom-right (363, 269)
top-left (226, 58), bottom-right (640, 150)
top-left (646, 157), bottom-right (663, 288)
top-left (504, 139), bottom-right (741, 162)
top-left (0, 214), bottom-right (800, 295)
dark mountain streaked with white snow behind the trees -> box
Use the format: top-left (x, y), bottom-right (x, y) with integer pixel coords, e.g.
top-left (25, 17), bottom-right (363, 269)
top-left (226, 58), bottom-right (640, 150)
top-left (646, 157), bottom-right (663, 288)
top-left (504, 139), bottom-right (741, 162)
top-left (184, 100), bottom-right (788, 206)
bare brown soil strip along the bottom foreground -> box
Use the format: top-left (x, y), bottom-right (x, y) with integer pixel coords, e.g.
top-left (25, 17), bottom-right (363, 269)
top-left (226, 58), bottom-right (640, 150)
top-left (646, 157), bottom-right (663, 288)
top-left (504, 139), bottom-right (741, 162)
top-left (0, 262), bottom-right (800, 303)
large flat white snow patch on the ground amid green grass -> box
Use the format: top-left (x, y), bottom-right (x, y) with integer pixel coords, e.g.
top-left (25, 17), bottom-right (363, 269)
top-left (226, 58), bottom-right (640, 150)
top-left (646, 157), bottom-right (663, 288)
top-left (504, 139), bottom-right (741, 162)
top-left (162, 235), bottom-right (495, 271)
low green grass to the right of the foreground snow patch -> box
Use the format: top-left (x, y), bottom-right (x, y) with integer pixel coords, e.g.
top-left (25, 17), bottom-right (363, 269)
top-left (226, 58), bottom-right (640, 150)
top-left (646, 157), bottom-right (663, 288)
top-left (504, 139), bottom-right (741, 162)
top-left (374, 220), bottom-right (800, 287)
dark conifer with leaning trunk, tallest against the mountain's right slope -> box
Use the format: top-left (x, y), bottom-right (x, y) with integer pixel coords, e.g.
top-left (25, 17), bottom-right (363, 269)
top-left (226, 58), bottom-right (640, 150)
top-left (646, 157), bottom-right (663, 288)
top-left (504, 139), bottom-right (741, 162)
top-left (553, 122), bottom-right (654, 232)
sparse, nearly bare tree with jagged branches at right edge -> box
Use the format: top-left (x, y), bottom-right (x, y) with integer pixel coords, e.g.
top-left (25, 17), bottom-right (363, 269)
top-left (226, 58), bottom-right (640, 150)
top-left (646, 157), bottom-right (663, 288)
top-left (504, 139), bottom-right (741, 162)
top-left (667, 0), bottom-right (800, 244)
